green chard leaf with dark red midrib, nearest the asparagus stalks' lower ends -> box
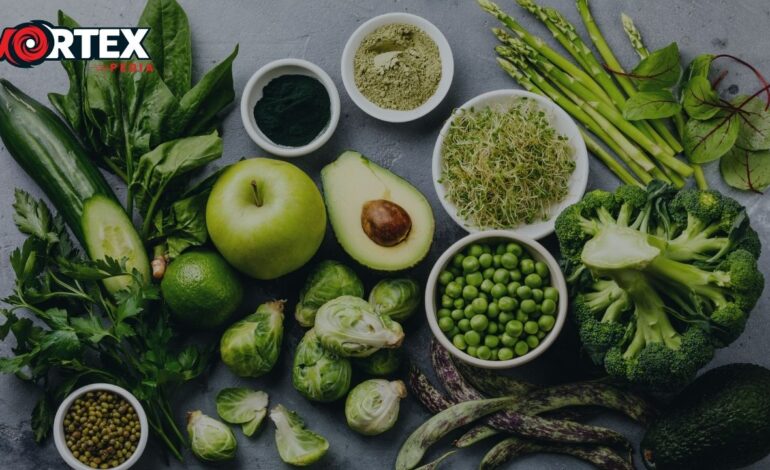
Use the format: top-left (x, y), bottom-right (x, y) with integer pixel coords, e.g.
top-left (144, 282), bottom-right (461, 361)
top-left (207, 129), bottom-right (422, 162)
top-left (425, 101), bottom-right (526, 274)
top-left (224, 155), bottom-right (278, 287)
top-left (682, 115), bottom-right (740, 163)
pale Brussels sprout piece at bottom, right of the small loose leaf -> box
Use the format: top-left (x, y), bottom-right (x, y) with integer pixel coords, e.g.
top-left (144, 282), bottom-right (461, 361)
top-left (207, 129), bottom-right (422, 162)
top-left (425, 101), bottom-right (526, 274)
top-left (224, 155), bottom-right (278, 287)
top-left (270, 405), bottom-right (329, 467)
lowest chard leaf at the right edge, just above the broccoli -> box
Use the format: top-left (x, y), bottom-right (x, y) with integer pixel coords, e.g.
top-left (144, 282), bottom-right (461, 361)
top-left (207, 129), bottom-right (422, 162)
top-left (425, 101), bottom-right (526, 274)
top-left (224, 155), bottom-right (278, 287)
top-left (719, 146), bottom-right (770, 193)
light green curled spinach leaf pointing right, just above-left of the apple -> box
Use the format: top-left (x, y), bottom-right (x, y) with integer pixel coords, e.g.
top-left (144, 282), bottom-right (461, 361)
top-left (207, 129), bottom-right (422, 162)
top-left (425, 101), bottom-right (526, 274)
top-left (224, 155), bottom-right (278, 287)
top-left (130, 133), bottom-right (222, 213)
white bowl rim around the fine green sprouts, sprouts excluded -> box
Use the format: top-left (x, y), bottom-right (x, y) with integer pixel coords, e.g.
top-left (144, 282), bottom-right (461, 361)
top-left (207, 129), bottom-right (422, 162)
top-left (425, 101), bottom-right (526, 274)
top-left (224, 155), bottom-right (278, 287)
top-left (433, 89), bottom-right (588, 239)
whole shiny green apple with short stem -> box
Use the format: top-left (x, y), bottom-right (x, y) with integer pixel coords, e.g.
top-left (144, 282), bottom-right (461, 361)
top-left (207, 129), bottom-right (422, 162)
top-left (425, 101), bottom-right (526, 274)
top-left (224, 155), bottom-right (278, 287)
top-left (206, 158), bottom-right (326, 279)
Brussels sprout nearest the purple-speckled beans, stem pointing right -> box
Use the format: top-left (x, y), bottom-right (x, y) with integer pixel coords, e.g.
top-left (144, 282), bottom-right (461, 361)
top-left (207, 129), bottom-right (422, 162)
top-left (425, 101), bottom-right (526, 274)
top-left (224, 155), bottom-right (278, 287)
top-left (345, 379), bottom-right (406, 436)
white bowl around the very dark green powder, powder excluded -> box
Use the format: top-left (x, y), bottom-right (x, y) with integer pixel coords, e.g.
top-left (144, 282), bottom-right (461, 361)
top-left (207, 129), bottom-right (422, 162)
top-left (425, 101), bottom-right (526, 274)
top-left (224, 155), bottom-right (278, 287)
top-left (241, 59), bottom-right (340, 157)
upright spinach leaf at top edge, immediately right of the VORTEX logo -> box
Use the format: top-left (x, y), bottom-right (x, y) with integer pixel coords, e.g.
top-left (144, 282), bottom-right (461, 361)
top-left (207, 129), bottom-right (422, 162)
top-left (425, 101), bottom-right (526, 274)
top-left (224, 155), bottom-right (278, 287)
top-left (139, 0), bottom-right (192, 97)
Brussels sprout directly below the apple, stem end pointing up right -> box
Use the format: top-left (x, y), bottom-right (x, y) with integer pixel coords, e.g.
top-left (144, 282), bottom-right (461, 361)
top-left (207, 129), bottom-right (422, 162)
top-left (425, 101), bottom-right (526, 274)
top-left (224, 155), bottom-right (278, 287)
top-left (219, 300), bottom-right (284, 377)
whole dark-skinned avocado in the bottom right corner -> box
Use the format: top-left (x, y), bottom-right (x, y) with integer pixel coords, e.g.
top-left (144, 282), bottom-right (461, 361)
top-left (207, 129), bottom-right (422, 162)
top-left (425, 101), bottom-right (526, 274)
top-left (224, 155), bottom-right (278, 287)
top-left (641, 364), bottom-right (770, 470)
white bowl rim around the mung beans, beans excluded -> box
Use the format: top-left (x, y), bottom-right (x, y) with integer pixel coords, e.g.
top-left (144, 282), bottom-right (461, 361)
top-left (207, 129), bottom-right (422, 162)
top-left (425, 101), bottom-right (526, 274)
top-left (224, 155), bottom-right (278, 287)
top-left (53, 383), bottom-right (149, 470)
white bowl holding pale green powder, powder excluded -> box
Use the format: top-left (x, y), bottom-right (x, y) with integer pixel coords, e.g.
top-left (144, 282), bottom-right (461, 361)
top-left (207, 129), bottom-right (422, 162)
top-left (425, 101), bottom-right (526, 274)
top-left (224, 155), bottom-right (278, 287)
top-left (342, 13), bottom-right (455, 122)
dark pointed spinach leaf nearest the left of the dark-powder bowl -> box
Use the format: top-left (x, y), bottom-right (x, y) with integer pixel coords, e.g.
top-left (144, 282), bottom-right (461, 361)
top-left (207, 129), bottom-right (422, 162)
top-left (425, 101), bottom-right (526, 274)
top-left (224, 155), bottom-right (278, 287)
top-left (180, 45), bottom-right (238, 135)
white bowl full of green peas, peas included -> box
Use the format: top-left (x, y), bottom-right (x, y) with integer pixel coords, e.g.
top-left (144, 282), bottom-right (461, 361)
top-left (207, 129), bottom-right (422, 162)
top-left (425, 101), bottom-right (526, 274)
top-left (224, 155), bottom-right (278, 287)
top-left (425, 230), bottom-right (567, 369)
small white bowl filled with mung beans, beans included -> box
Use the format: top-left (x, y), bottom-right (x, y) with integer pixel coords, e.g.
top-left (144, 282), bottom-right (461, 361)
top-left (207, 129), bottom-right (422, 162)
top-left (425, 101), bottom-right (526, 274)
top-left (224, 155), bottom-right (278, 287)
top-left (53, 383), bottom-right (148, 470)
